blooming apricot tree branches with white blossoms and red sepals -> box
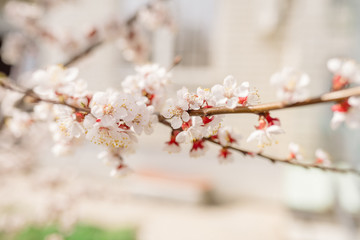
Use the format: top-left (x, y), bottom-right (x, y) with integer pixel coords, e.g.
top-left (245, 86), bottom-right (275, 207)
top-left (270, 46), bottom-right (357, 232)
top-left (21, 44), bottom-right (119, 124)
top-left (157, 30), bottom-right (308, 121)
top-left (0, 1), bottom-right (360, 176)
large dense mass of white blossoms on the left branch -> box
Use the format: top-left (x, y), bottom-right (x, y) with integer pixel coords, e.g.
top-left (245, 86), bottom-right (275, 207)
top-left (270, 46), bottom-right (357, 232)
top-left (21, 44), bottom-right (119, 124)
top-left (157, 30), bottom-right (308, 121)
top-left (2, 65), bottom-right (165, 175)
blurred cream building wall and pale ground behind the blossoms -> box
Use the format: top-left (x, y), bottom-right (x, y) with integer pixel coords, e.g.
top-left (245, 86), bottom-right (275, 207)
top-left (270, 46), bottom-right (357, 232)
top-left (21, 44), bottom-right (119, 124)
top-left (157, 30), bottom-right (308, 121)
top-left (0, 0), bottom-right (360, 240)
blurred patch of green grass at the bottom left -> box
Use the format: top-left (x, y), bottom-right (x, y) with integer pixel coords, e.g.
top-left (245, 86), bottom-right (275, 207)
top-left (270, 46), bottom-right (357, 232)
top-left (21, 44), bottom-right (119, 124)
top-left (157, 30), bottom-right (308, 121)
top-left (10, 224), bottom-right (136, 240)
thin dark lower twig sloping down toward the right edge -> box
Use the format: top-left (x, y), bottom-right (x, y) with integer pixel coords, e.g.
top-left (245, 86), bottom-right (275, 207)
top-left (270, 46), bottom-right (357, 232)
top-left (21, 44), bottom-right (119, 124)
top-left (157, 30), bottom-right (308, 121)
top-left (159, 115), bottom-right (360, 176)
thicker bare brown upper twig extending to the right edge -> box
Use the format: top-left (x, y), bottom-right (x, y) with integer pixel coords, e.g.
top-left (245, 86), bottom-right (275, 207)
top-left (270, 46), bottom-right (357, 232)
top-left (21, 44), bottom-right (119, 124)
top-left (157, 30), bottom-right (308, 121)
top-left (189, 87), bottom-right (360, 116)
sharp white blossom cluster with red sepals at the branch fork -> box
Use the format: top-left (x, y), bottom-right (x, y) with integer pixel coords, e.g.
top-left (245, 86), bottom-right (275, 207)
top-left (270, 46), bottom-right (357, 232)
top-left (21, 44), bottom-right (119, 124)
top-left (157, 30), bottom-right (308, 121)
top-left (161, 76), bottom-right (259, 161)
